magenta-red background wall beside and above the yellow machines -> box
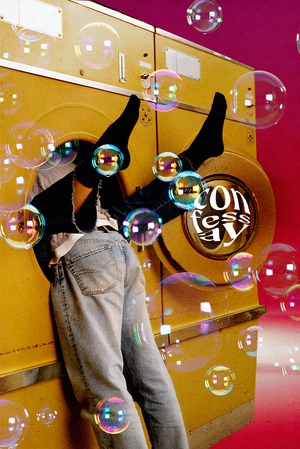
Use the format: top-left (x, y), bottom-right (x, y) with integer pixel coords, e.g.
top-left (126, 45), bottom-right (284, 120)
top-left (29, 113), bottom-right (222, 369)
top-left (90, 0), bottom-right (300, 449)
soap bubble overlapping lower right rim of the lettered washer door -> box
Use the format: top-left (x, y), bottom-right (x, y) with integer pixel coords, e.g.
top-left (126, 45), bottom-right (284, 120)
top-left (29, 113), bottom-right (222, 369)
top-left (223, 253), bottom-right (256, 292)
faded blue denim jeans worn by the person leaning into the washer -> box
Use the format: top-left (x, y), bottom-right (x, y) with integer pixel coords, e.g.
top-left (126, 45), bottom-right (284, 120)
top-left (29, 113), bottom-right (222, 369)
top-left (51, 228), bottom-right (188, 449)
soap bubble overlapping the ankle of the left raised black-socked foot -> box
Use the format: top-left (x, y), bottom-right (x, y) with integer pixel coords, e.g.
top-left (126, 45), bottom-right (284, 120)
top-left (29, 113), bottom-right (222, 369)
top-left (92, 144), bottom-right (124, 176)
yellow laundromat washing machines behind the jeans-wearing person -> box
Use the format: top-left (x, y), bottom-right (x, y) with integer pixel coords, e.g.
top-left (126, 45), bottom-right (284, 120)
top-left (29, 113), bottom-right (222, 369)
top-left (0, 0), bottom-right (275, 449)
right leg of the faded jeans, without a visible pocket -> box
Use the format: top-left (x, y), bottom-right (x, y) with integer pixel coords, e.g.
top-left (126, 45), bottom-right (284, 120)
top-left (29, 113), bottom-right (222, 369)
top-left (113, 233), bottom-right (189, 449)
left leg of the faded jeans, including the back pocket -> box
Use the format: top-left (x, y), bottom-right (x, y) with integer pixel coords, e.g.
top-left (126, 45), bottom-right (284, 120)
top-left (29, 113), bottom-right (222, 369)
top-left (51, 231), bottom-right (147, 449)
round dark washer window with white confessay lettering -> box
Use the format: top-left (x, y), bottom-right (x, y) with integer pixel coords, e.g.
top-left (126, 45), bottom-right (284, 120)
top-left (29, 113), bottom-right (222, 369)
top-left (184, 174), bottom-right (257, 259)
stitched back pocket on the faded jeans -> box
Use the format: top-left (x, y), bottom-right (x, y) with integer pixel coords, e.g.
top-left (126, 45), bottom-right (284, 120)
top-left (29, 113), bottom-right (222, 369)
top-left (65, 244), bottom-right (118, 295)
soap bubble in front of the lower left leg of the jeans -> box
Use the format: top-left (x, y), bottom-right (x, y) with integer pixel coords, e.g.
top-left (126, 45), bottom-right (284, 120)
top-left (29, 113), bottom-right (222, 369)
top-left (94, 398), bottom-right (131, 434)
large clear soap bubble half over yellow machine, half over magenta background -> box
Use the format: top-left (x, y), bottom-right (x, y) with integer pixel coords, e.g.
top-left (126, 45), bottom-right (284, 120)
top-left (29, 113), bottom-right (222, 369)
top-left (230, 71), bottom-right (286, 129)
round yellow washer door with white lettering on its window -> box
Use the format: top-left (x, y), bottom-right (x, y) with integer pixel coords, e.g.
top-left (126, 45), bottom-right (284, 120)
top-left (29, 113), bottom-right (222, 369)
top-left (155, 148), bottom-right (275, 285)
